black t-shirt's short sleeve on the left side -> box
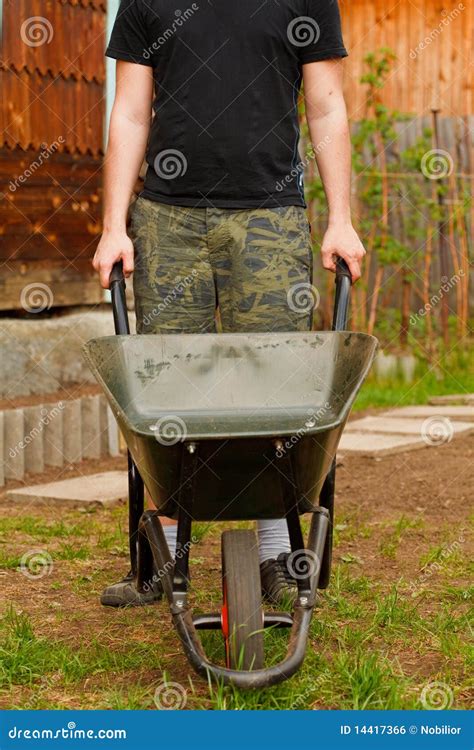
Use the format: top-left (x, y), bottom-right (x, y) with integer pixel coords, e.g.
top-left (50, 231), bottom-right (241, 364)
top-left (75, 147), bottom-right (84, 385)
top-left (105, 0), bottom-right (153, 65)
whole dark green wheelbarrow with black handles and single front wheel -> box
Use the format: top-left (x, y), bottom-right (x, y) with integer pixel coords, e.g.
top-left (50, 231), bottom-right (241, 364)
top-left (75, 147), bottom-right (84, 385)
top-left (84, 261), bottom-right (377, 688)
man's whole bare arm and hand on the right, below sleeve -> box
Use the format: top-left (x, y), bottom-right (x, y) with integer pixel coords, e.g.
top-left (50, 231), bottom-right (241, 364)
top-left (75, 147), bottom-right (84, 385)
top-left (303, 60), bottom-right (365, 281)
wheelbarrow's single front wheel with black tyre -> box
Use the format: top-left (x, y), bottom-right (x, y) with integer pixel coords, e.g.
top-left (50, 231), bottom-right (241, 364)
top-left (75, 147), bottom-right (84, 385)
top-left (222, 529), bottom-right (263, 671)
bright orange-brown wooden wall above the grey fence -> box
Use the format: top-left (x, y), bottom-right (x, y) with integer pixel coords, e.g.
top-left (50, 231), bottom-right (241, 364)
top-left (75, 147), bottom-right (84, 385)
top-left (340, 0), bottom-right (474, 119)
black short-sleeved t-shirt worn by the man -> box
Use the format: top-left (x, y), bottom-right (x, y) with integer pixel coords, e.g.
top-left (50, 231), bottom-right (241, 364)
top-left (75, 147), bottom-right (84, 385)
top-left (106, 0), bottom-right (347, 208)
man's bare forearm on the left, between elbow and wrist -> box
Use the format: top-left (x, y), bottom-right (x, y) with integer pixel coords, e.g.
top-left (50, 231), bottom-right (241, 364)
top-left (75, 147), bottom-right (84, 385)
top-left (104, 112), bottom-right (149, 232)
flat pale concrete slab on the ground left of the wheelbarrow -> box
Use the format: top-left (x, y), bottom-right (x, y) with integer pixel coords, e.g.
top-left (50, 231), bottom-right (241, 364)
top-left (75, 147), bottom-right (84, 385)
top-left (7, 471), bottom-right (128, 508)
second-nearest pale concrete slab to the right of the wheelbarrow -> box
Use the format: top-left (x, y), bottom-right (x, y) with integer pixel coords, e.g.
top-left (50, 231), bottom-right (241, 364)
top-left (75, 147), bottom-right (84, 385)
top-left (346, 412), bottom-right (474, 439)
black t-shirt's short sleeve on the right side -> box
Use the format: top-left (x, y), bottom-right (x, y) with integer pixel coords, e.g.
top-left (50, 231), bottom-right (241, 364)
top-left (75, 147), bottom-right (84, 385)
top-left (293, 0), bottom-right (347, 64)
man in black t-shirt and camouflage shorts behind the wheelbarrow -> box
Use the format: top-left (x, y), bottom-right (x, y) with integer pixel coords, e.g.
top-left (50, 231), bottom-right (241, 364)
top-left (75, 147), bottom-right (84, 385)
top-left (93, 0), bottom-right (365, 606)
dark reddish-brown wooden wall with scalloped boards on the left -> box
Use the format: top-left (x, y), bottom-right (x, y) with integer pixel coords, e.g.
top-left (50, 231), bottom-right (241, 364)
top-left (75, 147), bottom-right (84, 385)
top-left (0, 0), bottom-right (106, 310)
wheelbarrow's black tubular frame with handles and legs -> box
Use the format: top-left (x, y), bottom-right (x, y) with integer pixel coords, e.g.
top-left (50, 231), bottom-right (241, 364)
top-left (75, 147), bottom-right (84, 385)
top-left (109, 259), bottom-right (351, 688)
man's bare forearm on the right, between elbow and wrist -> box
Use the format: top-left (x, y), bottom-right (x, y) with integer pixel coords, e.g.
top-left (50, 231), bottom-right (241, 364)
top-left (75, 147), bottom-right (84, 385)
top-left (308, 102), bottom-right (351, 224)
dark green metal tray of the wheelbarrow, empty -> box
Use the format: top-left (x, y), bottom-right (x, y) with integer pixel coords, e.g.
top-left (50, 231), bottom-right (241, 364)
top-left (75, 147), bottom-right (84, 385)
top-left (87, 332), bottom-right (374, 521)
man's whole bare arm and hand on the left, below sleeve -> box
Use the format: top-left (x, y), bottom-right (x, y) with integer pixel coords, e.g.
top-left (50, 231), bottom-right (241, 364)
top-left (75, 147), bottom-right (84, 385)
top-left (92, 60), bottom-right (153, 289)
